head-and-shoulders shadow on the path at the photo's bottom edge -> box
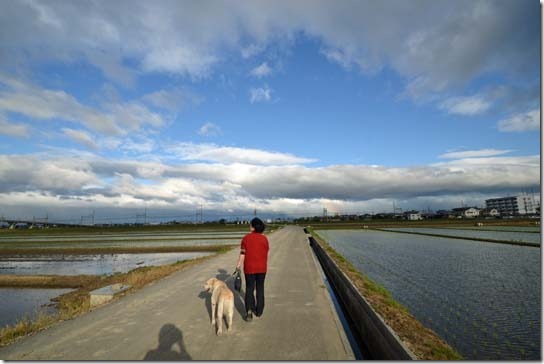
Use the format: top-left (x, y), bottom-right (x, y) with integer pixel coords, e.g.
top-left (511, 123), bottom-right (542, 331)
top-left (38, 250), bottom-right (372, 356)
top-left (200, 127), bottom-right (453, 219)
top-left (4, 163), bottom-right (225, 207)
top-left (144, 324), bottom-right (192, 361)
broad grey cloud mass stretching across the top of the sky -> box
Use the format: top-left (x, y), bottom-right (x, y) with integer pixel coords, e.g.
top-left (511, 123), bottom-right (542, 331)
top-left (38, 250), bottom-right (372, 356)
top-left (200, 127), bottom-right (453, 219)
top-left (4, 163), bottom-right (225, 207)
top-left (0, 0), bottom-right (540, 98)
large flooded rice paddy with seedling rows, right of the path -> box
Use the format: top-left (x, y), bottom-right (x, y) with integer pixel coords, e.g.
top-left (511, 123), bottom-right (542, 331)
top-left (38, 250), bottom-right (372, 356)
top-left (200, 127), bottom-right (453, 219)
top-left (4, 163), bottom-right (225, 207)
top-left (318, 230), bottom-right (541, 360)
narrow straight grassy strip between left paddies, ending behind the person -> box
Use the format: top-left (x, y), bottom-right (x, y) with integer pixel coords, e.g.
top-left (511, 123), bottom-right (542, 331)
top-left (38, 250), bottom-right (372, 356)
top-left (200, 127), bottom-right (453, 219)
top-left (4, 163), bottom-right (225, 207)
top-left (0, 244), bottom-right (238, 256)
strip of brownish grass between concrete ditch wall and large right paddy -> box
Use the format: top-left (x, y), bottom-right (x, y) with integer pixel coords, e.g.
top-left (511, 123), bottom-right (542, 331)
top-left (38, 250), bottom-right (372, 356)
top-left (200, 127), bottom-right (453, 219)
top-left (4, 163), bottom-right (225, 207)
top-left (308, 228), bottom-right (462, 360)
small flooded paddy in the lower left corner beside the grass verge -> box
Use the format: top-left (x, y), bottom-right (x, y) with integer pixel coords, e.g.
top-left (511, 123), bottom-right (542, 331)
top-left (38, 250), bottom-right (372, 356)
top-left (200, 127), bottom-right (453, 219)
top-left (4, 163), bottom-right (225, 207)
top-left (0, 288), bottom-right (71, 327)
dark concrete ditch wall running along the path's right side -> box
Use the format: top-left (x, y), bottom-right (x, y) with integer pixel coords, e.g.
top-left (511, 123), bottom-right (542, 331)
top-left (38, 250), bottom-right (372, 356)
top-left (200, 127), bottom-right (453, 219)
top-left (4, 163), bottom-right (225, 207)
top-left (308, 237), bottom-right (417, 360)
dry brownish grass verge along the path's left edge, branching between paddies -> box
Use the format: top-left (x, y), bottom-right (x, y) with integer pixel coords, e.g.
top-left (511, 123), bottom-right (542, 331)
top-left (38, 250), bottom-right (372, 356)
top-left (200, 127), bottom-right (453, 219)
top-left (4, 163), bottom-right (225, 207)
top-left (0, 246), bottom-right (232, 347)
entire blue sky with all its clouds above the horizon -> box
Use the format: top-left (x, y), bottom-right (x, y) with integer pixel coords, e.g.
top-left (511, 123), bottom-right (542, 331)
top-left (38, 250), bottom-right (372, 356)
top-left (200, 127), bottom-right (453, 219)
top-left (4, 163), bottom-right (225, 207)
top-left (0, 0), bottom-right (540, 219)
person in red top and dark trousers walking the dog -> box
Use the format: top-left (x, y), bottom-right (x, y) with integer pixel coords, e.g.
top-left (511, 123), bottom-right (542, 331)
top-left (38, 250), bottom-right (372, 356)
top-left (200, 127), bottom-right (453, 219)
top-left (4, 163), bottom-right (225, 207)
top-left (236, 217), bottom-right (269, 321)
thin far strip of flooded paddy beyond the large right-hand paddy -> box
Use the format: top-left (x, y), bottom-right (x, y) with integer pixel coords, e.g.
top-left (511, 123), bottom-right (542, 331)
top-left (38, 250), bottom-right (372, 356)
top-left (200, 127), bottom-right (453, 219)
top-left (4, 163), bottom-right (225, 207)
top-left (386, 228), bottom-right (540, 244)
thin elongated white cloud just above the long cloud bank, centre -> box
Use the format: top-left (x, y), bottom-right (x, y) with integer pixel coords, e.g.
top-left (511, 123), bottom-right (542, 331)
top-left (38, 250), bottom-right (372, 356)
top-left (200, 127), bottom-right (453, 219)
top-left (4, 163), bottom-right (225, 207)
top-left (167, 143), bottom-right (315, 165)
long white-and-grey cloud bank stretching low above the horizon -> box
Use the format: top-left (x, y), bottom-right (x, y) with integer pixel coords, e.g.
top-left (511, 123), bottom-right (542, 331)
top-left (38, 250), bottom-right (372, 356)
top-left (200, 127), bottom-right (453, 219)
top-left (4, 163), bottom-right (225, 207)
top-left (0, 148), bottom-right (540, 219)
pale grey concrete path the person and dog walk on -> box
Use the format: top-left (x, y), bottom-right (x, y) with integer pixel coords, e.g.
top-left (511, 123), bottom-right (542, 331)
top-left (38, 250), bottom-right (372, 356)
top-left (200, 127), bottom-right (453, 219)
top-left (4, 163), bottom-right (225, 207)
top-left (0, 226), bottom-right (354, 360)
